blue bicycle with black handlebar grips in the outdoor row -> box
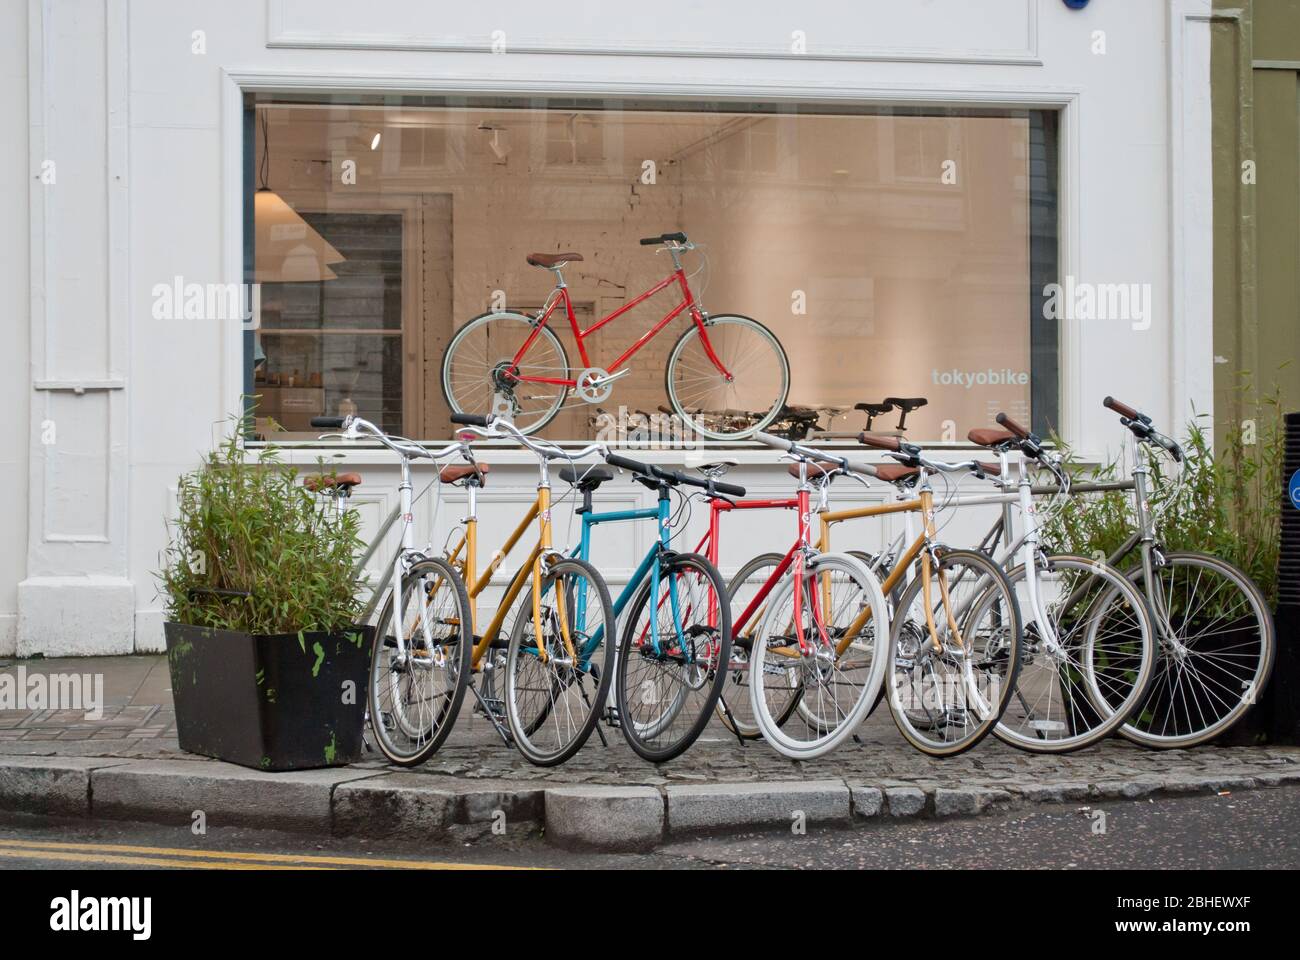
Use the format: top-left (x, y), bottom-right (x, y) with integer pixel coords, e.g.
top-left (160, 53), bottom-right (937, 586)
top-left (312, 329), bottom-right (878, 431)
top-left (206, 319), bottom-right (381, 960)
top-left (560, 454), bottom-right (745, 764)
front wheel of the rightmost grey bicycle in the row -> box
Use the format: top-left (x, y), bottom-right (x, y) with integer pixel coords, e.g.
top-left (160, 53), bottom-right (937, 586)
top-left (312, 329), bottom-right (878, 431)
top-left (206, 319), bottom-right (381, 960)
top-left (1119, 553), bottom-right (1277, 749)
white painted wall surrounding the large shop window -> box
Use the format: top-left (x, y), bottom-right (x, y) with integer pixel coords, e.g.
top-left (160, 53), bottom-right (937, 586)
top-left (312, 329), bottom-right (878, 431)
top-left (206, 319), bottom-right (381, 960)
top-left (0, 0), bottom-right (1210, 653)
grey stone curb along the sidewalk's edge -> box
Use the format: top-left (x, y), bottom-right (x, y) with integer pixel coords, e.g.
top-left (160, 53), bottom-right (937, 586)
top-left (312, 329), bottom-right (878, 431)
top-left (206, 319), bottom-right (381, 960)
top-left (0, 756), bottom-right (1300, 851)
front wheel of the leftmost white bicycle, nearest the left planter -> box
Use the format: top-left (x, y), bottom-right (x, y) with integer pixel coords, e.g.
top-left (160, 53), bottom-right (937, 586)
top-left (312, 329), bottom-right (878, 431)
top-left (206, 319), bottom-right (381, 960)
top-left (369, 558), bottom-right (473, 766)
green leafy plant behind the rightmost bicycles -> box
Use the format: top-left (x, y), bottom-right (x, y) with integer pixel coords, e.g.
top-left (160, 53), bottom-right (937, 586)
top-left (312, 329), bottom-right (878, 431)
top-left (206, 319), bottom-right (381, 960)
top-left (1045, 393), bottom-right (1284, 604)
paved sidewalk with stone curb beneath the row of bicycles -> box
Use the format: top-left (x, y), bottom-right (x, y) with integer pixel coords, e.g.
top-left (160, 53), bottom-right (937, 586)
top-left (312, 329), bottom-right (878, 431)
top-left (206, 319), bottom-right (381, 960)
top-left (0, 656), bottom-right (1300, 849)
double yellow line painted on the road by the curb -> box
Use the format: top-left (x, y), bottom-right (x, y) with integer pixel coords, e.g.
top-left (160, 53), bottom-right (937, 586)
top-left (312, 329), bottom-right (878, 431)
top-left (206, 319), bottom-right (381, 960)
top-left (0, 840), bottom-right (515, 870)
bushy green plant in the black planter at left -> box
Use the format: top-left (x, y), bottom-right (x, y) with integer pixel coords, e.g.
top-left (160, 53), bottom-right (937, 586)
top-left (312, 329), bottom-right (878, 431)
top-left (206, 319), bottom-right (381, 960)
top-left (157, 408), bottom-right (361, 633)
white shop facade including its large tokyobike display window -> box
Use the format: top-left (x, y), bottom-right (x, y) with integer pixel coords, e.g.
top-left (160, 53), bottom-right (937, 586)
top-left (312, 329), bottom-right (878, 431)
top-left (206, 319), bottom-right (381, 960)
top-left (0, 0), bottom-right (1214, 656)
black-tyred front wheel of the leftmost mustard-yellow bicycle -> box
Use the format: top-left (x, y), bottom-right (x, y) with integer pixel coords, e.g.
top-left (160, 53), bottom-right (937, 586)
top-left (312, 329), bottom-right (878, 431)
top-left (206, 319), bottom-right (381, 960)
top-left (504, 558), bottom-right (618, 766)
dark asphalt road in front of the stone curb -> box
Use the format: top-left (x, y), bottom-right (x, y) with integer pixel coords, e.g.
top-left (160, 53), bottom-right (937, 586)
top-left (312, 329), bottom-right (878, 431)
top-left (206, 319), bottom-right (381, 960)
top-left (0, 787), bottom-right (1300, 870)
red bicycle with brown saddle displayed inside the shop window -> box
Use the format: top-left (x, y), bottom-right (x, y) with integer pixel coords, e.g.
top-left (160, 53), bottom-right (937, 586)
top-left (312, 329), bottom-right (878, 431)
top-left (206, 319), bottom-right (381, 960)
top-left (442, 233), bottom-right (790, 440)
